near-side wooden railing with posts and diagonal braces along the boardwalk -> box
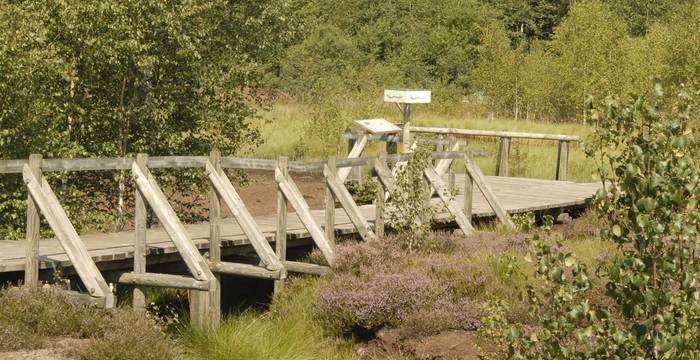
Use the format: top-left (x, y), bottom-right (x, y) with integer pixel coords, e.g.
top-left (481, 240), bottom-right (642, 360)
top-left (0, 150), bottom-right (513, 327)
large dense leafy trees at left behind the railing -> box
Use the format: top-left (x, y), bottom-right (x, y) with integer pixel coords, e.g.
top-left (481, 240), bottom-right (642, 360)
top-left (0, 0), bottom-right (294, 238)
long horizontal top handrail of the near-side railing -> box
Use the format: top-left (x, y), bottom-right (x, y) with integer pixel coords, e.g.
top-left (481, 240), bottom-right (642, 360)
top-left (0, 151), bottom-right (464, 174)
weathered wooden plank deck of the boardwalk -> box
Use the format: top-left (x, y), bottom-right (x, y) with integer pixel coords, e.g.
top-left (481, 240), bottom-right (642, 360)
top-left (0, 174), bottom-right (599, 272)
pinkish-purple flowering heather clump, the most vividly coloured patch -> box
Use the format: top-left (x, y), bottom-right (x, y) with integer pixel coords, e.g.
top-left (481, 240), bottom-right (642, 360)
top-left (316, 271), bottom-right (444, 332)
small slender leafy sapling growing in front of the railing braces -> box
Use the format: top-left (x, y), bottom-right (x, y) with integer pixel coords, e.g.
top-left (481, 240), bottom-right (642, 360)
top-left (387, 148), bottom-right (436, 250)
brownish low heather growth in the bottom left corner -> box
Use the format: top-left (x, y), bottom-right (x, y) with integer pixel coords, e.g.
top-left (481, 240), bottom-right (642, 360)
top-left (0, 287), bottom-right (177, 360)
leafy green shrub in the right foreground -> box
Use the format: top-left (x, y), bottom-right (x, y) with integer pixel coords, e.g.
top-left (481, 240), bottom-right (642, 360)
top-left (498, 85), bottom-right (700, 359)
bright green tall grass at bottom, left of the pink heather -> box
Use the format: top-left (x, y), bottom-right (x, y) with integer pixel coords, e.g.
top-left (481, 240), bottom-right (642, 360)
top-left (181, 279), bottom-right (355, 360)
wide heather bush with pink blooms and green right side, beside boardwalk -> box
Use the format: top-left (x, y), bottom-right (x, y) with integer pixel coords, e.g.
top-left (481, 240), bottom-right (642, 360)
top-left (315, 235), bottom-right (480, 337)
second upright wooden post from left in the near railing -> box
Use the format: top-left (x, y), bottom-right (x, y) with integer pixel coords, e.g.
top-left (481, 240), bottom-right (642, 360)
top-left (132, 154), bottom-right (148, 312)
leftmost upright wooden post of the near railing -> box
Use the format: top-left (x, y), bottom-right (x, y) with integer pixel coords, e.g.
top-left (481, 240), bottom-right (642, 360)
top-left (24, 154), bottom-right (42, 287)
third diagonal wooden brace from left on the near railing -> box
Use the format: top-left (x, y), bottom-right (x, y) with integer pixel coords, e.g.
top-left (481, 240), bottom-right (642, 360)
top-left (207, 163), bottom-right (282, 270)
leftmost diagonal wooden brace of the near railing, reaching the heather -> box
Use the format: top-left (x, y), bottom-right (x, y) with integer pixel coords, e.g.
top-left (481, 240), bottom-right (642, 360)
top-left (22, 164), bottom-right (115, 308)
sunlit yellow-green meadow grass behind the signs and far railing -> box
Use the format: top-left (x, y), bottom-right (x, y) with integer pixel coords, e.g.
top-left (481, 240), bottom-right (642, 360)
top-left (246, 102), bottom-right (596, 182)
